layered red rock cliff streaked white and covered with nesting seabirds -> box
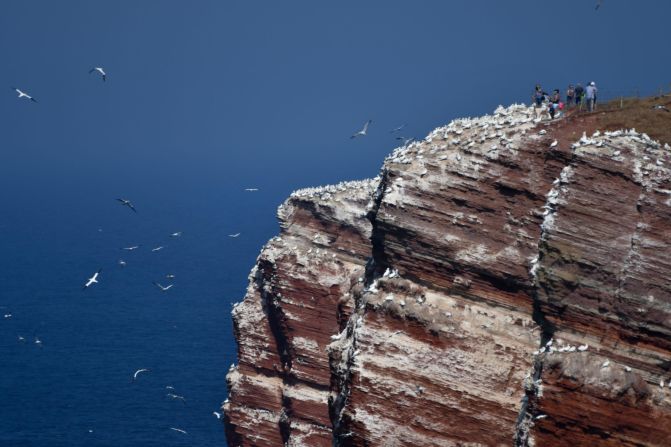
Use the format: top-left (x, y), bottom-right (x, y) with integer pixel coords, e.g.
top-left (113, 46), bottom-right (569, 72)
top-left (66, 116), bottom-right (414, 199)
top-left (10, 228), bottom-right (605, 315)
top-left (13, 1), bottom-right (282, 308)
top-left (223, 106), bottom-right (671, 447)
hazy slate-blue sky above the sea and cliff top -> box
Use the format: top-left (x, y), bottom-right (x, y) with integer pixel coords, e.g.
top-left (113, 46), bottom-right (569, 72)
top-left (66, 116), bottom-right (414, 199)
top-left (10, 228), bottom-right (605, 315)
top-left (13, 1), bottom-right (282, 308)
top-left (0, 0), bottom-right (671, 203)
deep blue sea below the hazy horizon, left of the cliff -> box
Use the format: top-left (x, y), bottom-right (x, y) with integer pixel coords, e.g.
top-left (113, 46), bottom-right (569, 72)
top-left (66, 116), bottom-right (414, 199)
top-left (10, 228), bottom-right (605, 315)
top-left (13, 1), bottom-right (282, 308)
top-left (0, 177), bottom-right (284, 447)
